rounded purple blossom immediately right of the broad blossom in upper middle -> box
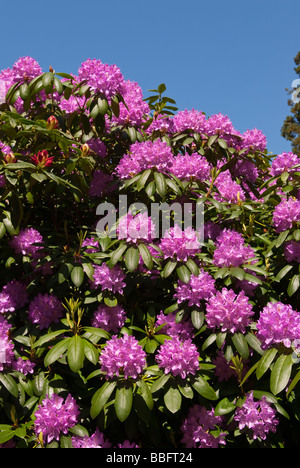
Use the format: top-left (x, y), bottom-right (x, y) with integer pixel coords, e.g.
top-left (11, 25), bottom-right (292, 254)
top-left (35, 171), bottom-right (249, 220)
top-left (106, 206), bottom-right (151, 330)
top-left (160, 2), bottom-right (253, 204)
top-left (170, 153), bottom-right (210, 180)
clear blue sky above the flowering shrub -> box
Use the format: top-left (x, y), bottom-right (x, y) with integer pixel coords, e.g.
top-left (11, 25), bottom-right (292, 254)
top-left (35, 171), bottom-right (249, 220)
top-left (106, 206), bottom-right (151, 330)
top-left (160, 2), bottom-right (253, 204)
top-left (0, 0), bottom-right (300, 154)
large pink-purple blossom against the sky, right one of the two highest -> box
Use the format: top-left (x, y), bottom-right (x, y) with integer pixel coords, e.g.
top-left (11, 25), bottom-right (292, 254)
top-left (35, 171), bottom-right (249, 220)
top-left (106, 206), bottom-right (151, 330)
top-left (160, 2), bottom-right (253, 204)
top-left (78, 59), bottom-right (124, 98)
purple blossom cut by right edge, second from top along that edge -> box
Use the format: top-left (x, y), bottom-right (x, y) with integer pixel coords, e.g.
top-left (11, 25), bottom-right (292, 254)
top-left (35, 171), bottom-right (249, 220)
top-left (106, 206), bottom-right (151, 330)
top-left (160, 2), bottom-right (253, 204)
top-left (273, 198), bottom-right (300, 232)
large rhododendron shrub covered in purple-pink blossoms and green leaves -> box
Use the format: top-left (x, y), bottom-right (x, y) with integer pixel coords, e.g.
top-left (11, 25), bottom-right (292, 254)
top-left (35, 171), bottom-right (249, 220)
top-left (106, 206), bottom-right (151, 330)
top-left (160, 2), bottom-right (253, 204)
top-left (0, 57), bottom-right (300, 451)
